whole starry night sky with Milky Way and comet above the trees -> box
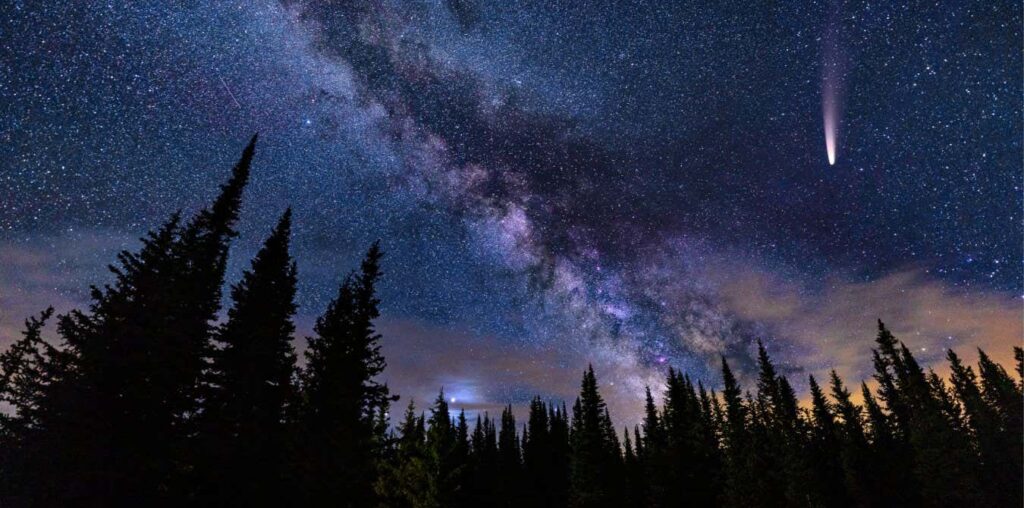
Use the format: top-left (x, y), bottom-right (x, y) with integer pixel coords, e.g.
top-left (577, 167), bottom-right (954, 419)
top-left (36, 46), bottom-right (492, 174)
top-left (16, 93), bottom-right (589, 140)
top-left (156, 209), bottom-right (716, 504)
top-left (0, 0), bottom-right (1024, 421)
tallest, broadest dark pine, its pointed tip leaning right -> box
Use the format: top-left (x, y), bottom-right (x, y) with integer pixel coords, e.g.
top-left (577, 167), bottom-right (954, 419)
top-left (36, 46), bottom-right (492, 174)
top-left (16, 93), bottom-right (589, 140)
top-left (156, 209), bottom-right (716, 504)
top-left (43, 136), bottom-right (256, 506)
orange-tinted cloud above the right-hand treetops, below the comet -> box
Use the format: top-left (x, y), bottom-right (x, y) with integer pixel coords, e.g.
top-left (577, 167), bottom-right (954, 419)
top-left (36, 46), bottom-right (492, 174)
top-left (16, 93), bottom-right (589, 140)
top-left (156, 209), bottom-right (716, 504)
top-left (720, 268), bottom-right (1024, 389)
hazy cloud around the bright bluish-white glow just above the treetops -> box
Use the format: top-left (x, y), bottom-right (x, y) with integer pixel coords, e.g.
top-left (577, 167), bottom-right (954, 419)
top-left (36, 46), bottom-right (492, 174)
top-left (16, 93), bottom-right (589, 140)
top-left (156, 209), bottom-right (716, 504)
top-left (380, 319), bottom-right (664, 425)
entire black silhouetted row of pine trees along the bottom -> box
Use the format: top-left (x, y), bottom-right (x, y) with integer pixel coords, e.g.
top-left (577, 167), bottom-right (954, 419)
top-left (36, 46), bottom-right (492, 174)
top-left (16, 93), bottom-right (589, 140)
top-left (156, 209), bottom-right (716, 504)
top-left (0, 136), bottom-right (1024, 508)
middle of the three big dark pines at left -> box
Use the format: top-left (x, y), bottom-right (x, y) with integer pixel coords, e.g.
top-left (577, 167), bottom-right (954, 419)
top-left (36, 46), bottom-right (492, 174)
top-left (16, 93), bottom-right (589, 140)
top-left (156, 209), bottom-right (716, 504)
top-left (201, 210), bottom-right (296, 506)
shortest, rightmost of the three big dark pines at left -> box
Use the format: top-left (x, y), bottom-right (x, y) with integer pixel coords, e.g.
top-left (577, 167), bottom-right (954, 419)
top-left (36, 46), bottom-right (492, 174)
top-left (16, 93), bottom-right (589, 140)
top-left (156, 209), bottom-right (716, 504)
top-left (300, 244), bottom-right (390, 507)
